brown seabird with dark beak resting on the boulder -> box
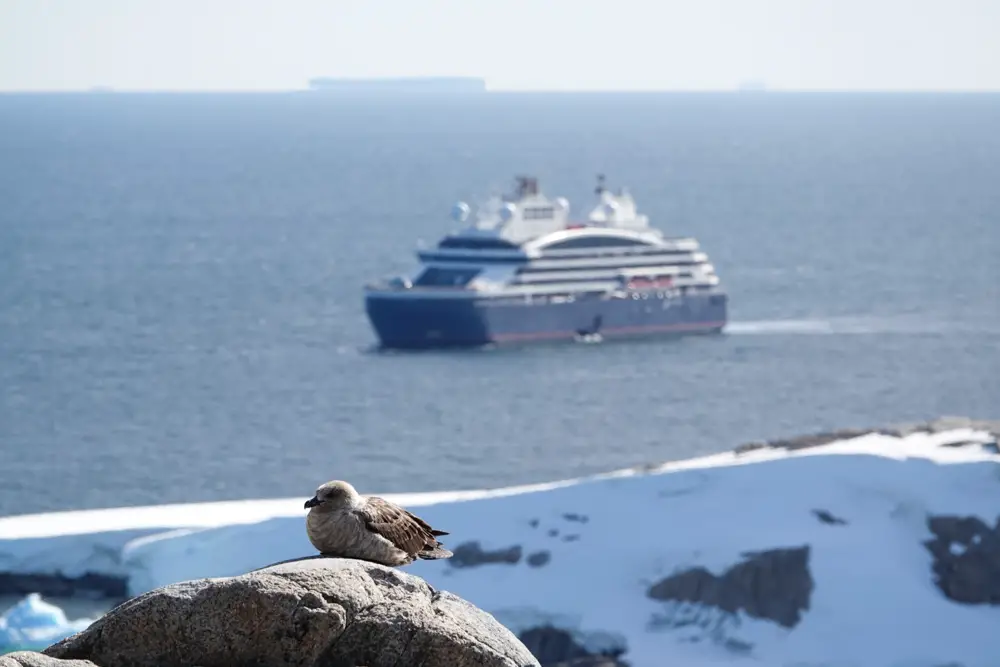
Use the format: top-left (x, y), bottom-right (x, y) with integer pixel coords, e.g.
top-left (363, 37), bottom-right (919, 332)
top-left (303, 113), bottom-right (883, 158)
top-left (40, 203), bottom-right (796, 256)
top-left (304, 480), bottom-right (454, 567)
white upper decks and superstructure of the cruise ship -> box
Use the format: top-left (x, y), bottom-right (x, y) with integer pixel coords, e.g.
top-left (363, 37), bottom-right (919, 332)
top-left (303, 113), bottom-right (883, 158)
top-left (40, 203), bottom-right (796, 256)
top-left (397, 176), bottom-right (719, 295)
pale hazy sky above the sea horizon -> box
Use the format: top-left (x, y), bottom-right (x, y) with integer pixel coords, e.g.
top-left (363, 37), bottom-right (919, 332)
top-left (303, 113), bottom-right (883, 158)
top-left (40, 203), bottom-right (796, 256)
top-left (0, 0), bottom-right (1000, 91)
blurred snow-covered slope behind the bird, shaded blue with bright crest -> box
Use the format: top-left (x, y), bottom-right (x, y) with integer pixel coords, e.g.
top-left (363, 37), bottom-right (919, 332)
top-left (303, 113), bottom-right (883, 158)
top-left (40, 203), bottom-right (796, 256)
top-left (0, 429), bottom-right (1000, 667)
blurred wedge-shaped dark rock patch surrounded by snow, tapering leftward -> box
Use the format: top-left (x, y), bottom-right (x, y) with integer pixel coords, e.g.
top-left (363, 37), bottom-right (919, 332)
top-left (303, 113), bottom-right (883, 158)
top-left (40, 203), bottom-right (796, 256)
top-left (647, 545), bottom-right (814, 628)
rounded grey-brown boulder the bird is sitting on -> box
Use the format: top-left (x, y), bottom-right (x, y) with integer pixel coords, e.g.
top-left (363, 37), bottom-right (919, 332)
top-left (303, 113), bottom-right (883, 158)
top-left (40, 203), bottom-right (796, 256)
top-left (44, 558), bottom-right (538, 667)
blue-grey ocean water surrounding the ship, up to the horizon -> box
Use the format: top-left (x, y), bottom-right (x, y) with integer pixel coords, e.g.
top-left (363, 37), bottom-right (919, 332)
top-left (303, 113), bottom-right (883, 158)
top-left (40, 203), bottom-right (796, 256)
top-left (0, 93), bottom-right (1000, 515)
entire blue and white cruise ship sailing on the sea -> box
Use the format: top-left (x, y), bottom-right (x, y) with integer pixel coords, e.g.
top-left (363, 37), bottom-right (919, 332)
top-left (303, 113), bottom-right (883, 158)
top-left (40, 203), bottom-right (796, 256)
top-left (365, 176), bottom-right (728, 349)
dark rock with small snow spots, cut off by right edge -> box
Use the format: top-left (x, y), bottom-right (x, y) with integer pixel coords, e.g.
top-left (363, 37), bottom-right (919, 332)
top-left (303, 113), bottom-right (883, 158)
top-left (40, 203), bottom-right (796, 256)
top-left (924, 516), bottom-right (1000, 605)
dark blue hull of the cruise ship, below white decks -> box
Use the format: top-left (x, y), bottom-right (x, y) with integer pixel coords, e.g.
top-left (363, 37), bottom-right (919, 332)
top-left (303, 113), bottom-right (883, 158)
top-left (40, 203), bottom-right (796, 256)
top-left (365, 290), bottom-right (727, 349)
